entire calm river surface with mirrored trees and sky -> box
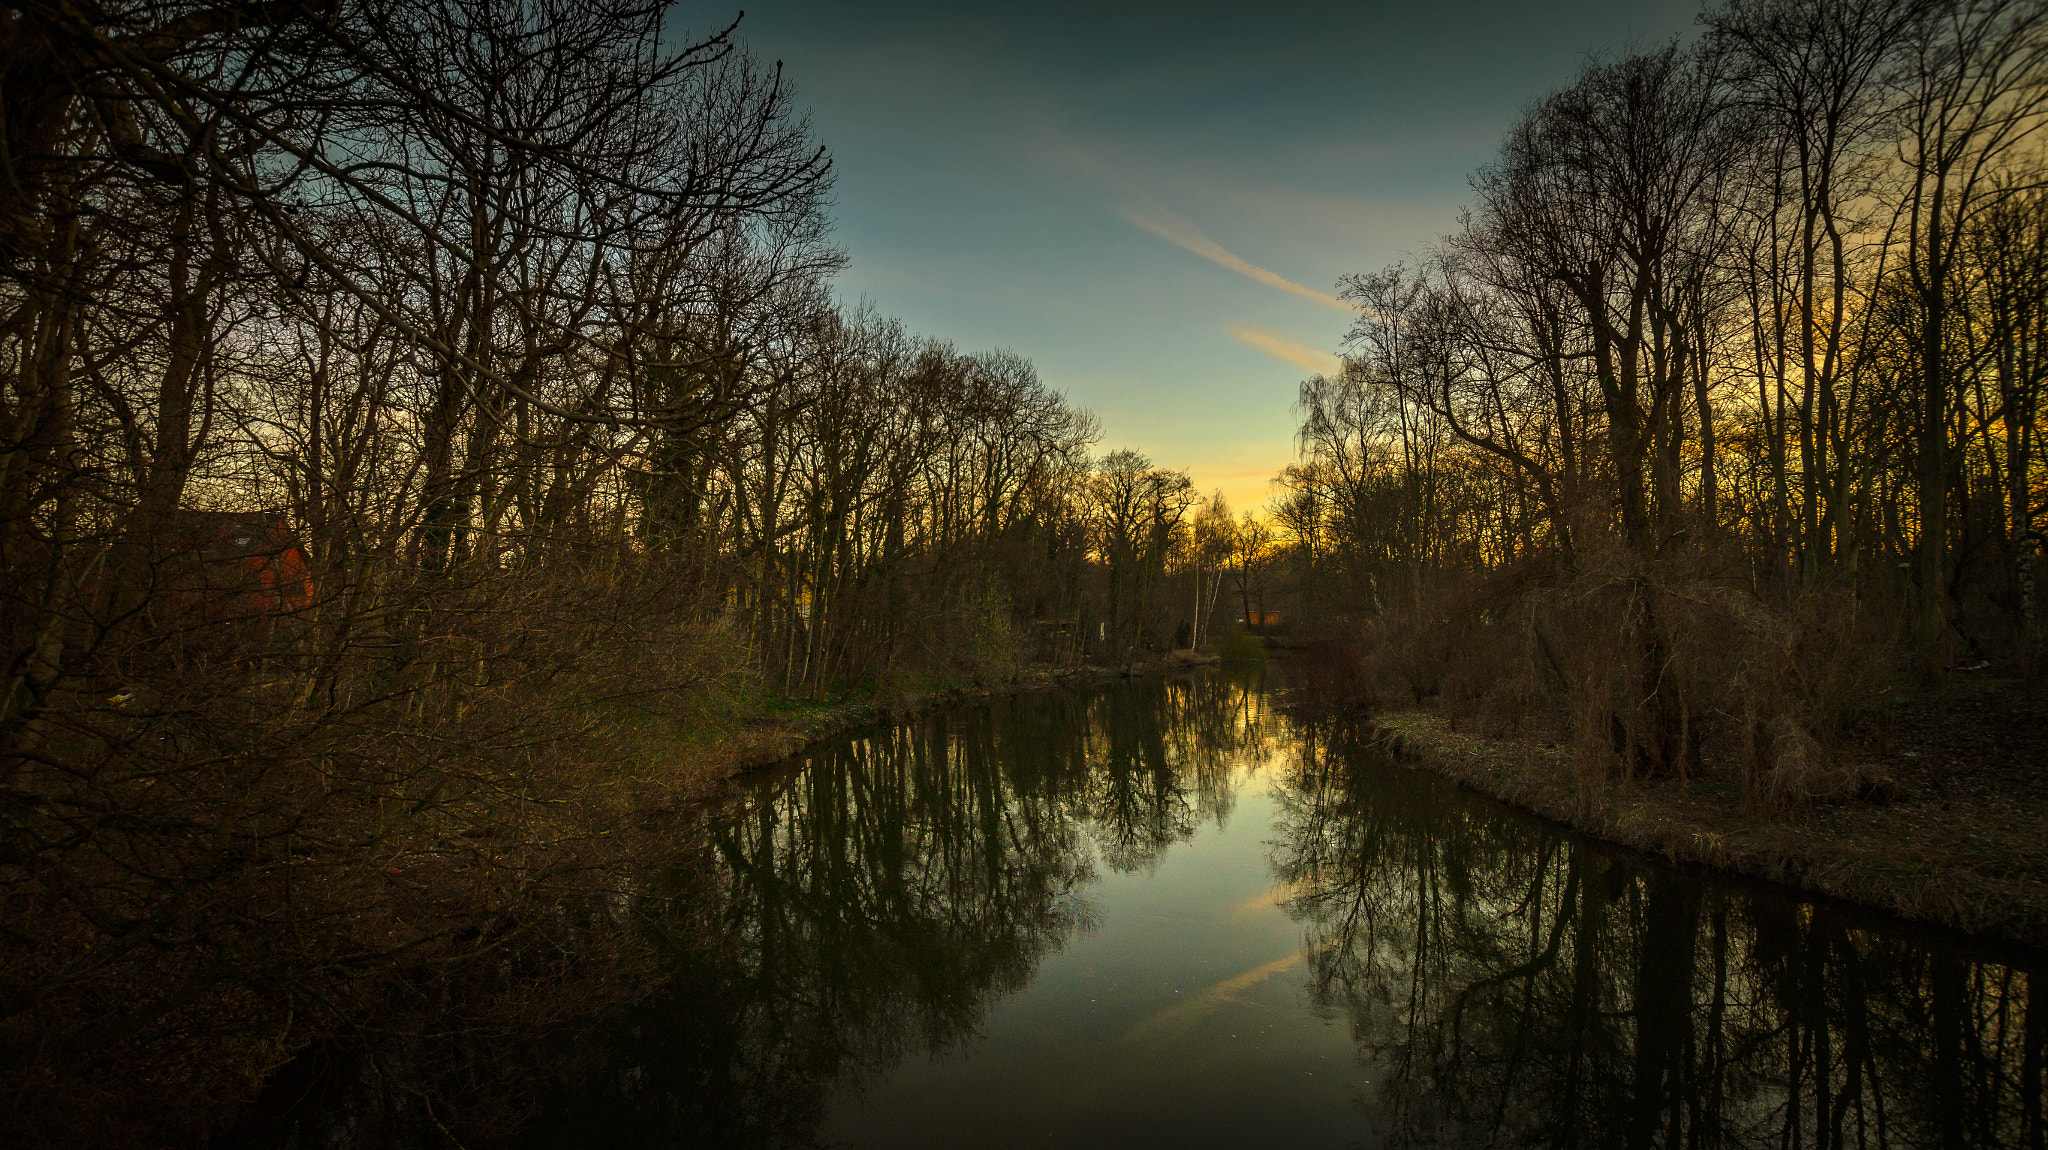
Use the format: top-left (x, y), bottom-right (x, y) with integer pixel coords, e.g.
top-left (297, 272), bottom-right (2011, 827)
top-left (499, 673), bottom-right (2048, 1148)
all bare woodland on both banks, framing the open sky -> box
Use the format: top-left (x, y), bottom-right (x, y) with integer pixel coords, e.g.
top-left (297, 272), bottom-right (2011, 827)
top-left (0, 0), bottom-right (2048, 1140)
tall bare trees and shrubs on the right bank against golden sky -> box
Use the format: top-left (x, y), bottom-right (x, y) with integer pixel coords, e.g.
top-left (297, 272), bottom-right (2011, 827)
top-left (1280, 0), bottom-right (2048, 802)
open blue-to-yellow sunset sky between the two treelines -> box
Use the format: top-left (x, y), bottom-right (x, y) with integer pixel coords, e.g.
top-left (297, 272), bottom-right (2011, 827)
top-left (712, 0), bottom-right (1700, 510)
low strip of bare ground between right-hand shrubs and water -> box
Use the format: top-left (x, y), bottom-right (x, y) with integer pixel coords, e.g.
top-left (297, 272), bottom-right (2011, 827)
top-left (1343, 677), bottom-right (2048, 947)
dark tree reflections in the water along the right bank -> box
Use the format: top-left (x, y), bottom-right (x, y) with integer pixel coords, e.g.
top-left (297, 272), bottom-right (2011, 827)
top-left (1274, 726), bottom-right (2048, 1150)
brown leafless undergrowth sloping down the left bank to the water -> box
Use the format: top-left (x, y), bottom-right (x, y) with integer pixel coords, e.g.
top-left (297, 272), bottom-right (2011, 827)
top-left (0, 581), bottom-right (1214, 1146)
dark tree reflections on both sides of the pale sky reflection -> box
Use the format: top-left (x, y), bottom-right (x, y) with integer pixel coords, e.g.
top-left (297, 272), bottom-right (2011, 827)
top-left (235, 675), bottom-right (2048, 1150)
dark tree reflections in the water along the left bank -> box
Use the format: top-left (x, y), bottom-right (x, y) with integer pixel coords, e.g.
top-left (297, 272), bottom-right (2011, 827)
top-left (509, 675), bottom-right (1278, 1146)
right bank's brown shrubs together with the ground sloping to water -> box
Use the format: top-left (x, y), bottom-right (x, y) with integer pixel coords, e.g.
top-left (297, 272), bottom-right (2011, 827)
top-left (1317, 538), bottom-right (2048, 945)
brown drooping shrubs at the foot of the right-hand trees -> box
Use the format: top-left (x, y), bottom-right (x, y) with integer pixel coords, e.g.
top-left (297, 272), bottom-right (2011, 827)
top-left (1354, 523), bottom-right (1903, 814)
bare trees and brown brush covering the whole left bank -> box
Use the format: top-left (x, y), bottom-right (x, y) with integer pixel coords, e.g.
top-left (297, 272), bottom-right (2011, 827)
top-left (0, 0), bottom-right (1219, 1138)
